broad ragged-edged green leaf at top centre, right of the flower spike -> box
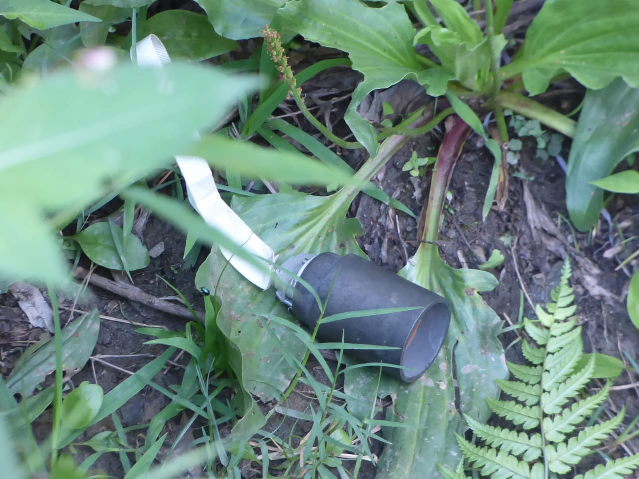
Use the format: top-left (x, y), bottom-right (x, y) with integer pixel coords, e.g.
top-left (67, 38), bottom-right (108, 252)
top-left (278, 0), bottom-right (453, 156)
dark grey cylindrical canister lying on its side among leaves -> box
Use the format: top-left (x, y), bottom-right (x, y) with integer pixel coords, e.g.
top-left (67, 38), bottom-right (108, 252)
top-left (277, 253), bottom-right (450, 382)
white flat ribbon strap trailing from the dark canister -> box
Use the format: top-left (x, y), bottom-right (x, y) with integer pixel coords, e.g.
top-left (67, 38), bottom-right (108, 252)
top-left (136, 35), bottom-right (275, 289)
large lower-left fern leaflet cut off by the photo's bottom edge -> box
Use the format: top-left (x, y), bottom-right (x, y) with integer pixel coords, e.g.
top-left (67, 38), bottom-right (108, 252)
top-left (457, 434), bottom-right (537, 479)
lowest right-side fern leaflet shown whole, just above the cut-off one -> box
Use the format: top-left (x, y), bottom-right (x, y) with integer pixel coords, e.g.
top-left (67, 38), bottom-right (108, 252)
top-left (546, 408), bottom-right (625, 474)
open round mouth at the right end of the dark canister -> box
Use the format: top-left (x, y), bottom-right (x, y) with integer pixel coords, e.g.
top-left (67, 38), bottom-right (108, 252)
top-left (400, 303), bottom-right (450, 382)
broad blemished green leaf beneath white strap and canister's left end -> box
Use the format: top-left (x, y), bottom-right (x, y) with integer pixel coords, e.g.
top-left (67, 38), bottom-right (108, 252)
top-left (196, 190), bottom-right (363, 401)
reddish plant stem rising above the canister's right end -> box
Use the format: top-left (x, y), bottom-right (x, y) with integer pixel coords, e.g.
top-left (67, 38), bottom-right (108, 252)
top-left (422, 115), bottom-right (471, 243)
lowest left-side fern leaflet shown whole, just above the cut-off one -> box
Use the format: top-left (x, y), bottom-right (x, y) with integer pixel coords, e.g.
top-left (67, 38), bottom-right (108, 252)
top-left (464, 414), bottom-right (542, 461)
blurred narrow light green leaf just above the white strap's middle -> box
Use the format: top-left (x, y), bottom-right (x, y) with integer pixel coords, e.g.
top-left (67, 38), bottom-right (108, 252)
top-left (191, 135), bottom-right (352, 185)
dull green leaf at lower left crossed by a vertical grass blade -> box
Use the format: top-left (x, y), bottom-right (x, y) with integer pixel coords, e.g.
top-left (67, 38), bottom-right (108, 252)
top-left (6, 309), bottom-right (100, 397)
